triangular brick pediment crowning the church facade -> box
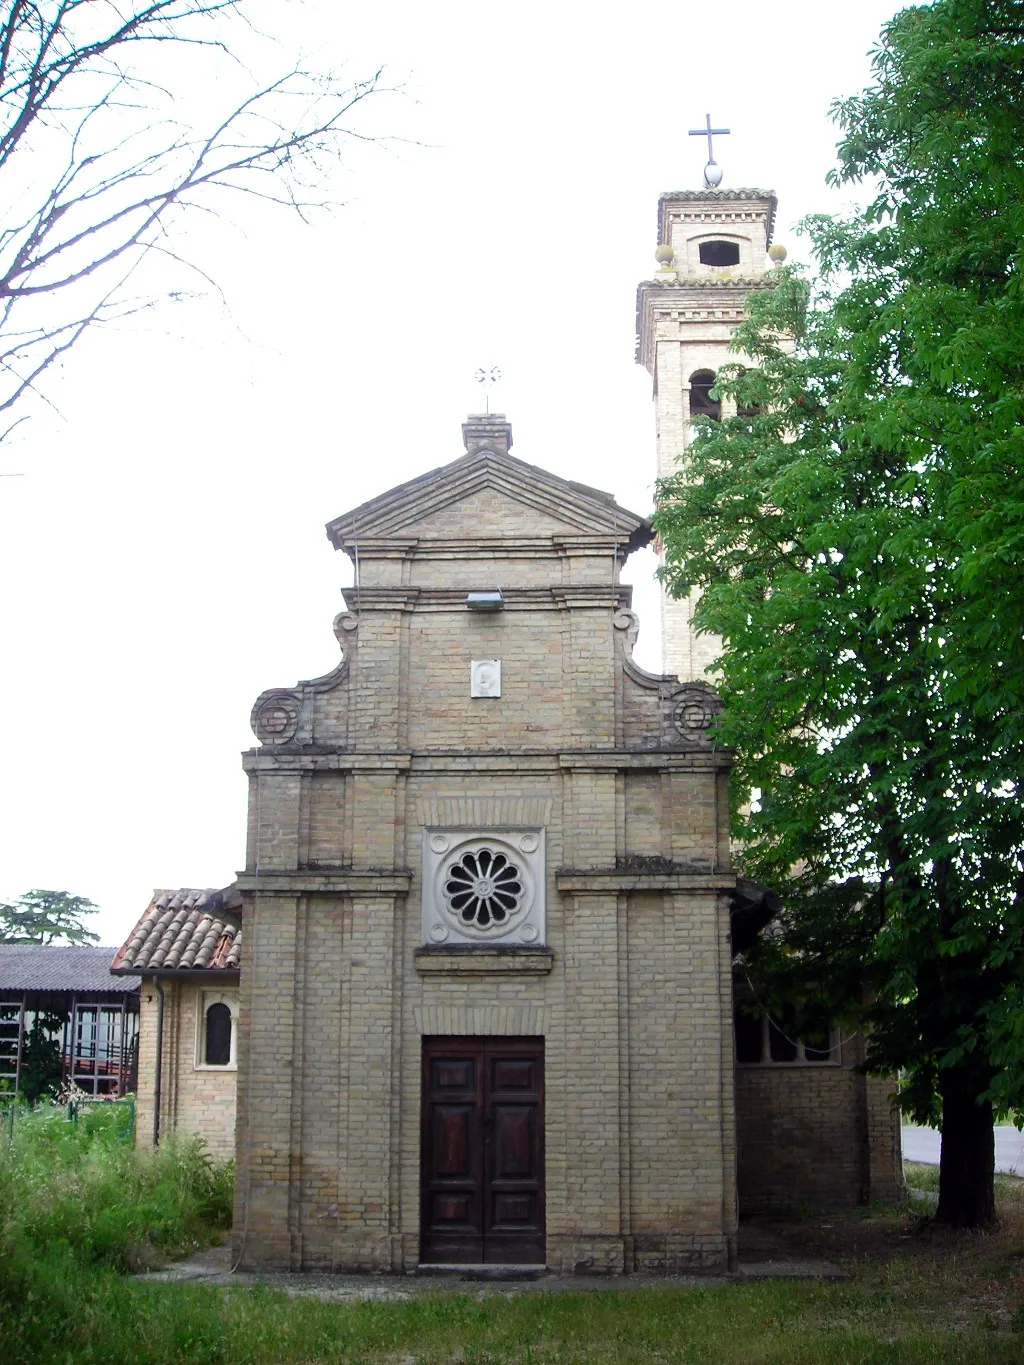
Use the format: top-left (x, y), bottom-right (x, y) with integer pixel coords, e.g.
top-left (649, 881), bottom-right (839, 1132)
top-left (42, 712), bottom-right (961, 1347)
top-left (328, 450), bottom-right (653, 549)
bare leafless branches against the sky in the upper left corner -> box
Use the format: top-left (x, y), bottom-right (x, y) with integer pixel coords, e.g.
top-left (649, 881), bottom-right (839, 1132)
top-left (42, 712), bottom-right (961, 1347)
top-left (0, 0), bottom-right (380, 440)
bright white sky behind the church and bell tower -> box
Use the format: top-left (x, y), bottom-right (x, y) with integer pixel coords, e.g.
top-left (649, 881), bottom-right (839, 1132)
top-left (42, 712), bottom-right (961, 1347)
top-left (0, 0), bottom-right (898, 943)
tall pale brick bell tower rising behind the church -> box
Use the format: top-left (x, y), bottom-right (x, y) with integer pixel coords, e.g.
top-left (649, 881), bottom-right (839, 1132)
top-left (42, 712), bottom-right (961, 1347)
top-left (636, 189), bottom-right (785, 681)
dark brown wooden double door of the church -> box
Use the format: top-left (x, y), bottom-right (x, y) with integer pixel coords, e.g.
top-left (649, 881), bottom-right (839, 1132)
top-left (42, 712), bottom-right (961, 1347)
top-left (419, 1037), bottom-right (545, 1265)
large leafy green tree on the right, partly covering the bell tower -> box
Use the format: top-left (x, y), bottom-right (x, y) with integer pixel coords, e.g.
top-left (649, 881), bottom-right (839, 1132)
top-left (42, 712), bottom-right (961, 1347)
top-left (655, 0), bottom-right (1024, 1226)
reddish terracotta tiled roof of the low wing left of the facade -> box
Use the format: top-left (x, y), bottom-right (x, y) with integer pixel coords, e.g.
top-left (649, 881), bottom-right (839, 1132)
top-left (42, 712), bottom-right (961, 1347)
top-left (111, 886), bottom-right (242, 973)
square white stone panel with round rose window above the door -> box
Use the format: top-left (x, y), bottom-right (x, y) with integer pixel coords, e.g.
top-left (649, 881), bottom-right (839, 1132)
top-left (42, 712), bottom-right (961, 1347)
top-left (423, 829), bottom-right (545, 947)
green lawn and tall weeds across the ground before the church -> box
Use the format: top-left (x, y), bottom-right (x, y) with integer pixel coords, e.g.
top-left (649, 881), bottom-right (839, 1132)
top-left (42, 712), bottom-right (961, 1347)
top-left (0, 1111), bottom-right (1024, 1365)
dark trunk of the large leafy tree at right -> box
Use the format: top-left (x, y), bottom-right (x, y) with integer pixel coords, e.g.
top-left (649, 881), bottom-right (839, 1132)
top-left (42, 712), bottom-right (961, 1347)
top-left (935, 1076), bottom-right (995, 1227)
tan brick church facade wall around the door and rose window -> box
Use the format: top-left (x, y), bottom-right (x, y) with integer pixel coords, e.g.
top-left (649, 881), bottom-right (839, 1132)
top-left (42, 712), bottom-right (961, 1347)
top-left (235, 398), bottom-right (883, 1274)
